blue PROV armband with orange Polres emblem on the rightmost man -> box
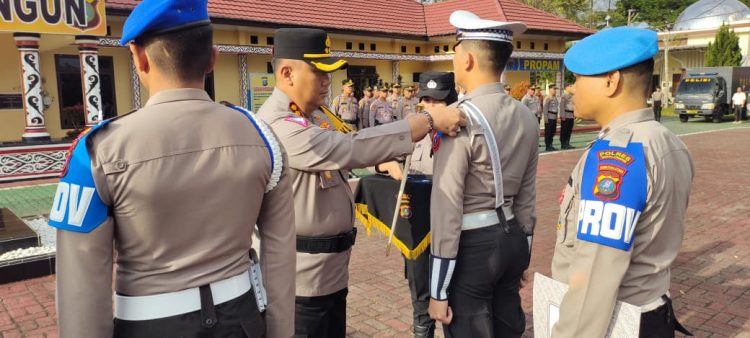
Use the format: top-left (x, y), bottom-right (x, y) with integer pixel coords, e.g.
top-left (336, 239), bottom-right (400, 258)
top-left (577, 140), bottom-right (648, 251)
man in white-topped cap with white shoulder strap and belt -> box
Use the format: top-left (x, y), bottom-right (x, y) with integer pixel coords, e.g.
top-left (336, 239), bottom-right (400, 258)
top-left (429, 11), bottom-right (539, 338)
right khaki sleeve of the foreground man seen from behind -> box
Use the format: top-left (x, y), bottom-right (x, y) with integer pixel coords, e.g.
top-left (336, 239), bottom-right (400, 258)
top-left (258, 155), bottom-right (297, 338)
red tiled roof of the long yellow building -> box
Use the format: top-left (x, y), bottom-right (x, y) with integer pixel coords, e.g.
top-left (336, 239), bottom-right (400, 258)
top-left (106, 0), bottom-right (593, 37)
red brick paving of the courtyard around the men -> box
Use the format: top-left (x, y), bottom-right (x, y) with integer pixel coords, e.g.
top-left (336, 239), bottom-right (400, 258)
top-left (0, 120), bottom-right (750, 338)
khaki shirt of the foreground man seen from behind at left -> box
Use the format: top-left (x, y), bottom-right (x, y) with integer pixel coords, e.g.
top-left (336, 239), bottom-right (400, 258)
top-left (57, 89), bottom-right (295, 338)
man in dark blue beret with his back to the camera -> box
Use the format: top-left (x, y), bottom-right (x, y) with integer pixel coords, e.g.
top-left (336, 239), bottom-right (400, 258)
top-left (49, 0), bottom-right (295, 338)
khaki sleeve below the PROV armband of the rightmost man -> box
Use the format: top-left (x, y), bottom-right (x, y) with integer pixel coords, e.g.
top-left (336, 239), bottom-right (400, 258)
top-left (552, 240), bottom-right (633, 338)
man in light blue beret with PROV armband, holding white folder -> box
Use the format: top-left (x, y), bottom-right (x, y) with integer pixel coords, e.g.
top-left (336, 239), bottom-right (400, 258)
top-left (552, 27), bottom-right (694, 338)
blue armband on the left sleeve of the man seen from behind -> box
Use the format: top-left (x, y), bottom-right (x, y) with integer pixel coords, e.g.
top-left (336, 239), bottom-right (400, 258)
top-left (48, 116), bottom-right (124, 233)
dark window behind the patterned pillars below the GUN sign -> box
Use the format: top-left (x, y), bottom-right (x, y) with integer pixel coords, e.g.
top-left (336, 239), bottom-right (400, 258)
top-left (55, 55), bottom-right (117, 129)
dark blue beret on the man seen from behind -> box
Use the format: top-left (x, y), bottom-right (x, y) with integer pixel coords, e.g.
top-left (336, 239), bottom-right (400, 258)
top-left (120, 0), bottom-right (211, 46)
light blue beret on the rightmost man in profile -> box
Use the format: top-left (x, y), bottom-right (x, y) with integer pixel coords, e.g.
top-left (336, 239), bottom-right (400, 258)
top-left (564, 27), bottom-right (659, 75)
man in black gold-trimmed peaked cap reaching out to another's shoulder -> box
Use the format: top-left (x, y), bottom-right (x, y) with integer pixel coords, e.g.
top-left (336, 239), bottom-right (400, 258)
top-left (258, 28), bottom-right (463, 338)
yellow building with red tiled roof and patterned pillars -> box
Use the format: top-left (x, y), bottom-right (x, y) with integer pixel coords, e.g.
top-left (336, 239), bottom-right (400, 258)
top-left (0, 0), bottom-right (592, 180)
